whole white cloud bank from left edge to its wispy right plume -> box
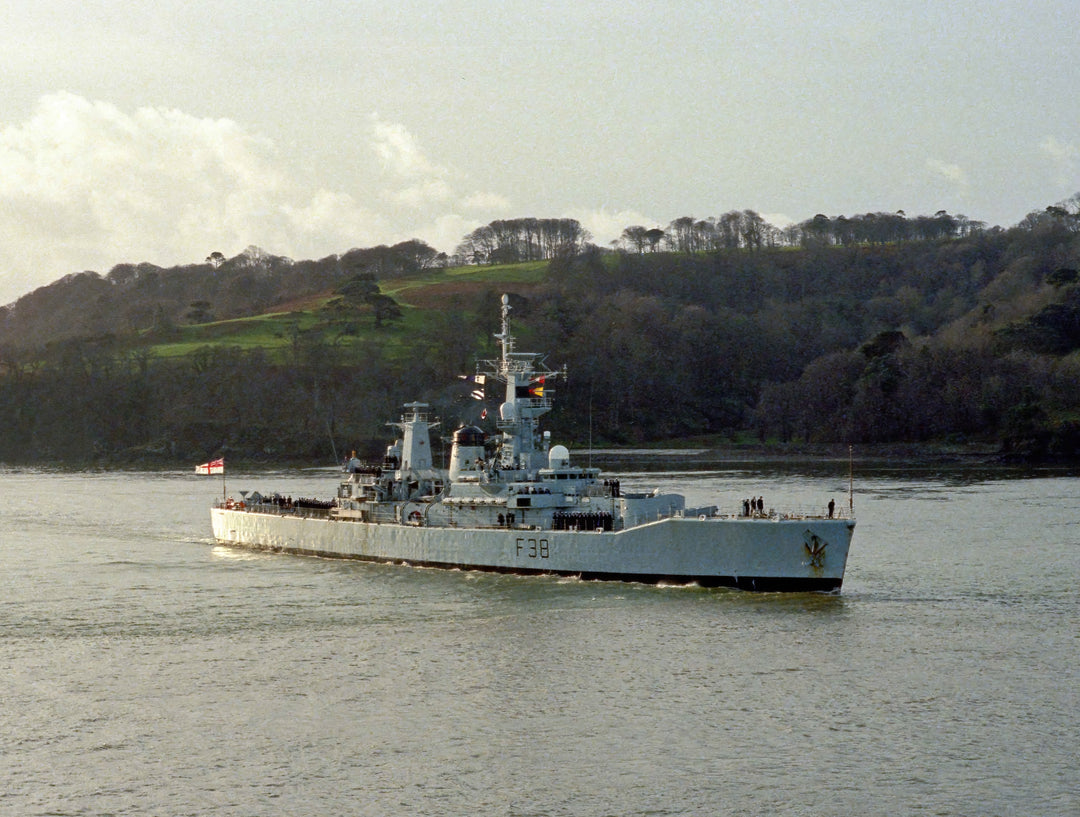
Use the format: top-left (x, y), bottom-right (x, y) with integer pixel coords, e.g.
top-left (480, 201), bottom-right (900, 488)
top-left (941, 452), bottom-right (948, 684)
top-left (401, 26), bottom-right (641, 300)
top-left (0, 93), bottom-right (504, 304)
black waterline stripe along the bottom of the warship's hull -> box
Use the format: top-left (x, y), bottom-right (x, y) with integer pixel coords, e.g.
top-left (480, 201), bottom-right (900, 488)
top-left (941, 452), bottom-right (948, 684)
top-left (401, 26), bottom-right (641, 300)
top-left (220, 541), bottom-right (843, 593)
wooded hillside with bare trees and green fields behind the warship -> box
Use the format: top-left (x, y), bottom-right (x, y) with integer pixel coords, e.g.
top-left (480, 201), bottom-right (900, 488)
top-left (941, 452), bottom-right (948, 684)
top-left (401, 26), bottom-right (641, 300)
top-left (0, 197), bottom-right (1080, 464)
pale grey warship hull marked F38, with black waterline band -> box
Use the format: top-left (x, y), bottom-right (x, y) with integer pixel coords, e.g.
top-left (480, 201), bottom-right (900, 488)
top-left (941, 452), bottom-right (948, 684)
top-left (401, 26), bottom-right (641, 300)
top-left (211, 507), bottom-right (854, 591)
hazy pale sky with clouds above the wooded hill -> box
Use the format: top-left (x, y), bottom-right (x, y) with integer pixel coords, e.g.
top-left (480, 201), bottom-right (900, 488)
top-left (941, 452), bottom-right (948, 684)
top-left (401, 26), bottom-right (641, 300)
top-left (0, 0), bottom-right (1080, 304)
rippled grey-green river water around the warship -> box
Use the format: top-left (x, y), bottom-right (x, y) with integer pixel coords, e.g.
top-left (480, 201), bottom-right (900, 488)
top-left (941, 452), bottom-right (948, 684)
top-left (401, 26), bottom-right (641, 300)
top-left (0, 464), bottom-right (1080, 817)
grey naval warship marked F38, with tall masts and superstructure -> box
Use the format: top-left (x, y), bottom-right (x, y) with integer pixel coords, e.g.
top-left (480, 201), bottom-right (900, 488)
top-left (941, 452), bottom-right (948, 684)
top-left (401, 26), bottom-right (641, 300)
top-left (211, 295), bottom-right (855, 591)
